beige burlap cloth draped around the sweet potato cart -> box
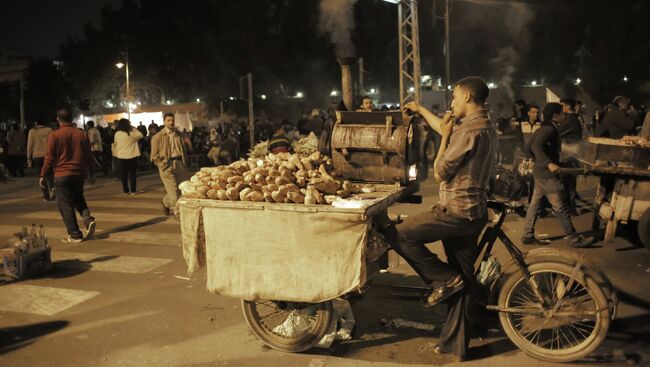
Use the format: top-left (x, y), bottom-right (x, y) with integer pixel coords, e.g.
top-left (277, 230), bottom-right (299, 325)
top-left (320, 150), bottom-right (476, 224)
top-left (180, 187), bottom-right (402, 303)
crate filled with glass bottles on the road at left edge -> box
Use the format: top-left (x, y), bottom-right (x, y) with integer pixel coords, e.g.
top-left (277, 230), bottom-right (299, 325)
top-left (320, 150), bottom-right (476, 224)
top-left (2, 224), bottom-right (52, 279)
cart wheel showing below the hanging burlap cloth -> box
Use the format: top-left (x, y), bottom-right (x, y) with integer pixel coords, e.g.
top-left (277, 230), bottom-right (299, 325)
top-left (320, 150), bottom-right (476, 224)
top-left (242, 300), bottom-right (332, 352)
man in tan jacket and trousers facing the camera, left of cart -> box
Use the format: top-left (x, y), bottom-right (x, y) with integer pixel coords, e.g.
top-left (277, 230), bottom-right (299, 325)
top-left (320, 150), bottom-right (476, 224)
top-left (151, 113), bottom-right (187, 215)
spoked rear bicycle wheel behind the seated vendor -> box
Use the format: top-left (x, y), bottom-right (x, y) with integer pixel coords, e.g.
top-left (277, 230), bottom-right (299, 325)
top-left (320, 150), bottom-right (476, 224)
top-left (498, 262), bottom-right (610, 362)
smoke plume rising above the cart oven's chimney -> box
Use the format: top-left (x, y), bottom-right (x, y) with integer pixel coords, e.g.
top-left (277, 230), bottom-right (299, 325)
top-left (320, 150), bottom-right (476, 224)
top-left (318, 0), bottom-right (357, 58)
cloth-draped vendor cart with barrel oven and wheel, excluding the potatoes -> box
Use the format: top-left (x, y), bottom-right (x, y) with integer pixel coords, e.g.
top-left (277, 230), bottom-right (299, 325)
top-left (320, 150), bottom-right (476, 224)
top-left (179, 111), bottom-right (422, 352)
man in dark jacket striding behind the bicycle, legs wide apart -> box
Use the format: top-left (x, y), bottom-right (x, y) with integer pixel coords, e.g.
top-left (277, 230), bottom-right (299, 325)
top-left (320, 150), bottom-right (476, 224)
top-left (521, 103), bottom-right (593, 247)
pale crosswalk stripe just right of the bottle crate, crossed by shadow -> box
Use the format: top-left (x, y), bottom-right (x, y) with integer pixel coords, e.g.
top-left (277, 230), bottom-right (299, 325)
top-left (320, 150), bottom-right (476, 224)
top-left (52, 251), bottom-right (172, 274)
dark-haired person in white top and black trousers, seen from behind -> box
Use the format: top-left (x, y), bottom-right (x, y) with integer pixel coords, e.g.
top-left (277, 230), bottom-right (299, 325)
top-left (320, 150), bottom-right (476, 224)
top-left (113, 119), bottom-right (144, 195)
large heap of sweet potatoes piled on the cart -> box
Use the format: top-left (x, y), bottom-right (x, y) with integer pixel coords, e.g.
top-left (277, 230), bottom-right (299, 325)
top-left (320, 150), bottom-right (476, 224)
top-left (179, 152), bottom-right (360, 205)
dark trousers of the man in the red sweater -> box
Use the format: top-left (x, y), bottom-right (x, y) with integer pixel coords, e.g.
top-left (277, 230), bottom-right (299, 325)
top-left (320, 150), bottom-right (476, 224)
top-left (54, 176), bottom-right (95, 239)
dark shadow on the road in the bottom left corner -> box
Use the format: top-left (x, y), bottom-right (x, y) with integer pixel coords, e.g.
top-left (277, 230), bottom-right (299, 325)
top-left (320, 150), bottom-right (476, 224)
top-left (0, 320), bottom-right (70, 355)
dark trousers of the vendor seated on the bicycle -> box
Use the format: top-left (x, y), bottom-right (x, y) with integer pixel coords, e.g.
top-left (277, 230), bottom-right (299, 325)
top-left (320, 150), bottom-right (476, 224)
top-left (387, 205), bottom-right (487, 356)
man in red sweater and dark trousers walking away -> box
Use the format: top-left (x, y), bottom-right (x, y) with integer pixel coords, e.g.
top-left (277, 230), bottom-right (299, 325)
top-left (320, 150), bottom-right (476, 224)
top-left (39, 107), bottom-right (96, 243)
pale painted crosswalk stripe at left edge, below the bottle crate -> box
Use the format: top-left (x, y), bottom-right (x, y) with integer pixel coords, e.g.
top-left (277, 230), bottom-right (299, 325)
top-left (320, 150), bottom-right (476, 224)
top-left (0, 284), bottom-right (99, 316)
